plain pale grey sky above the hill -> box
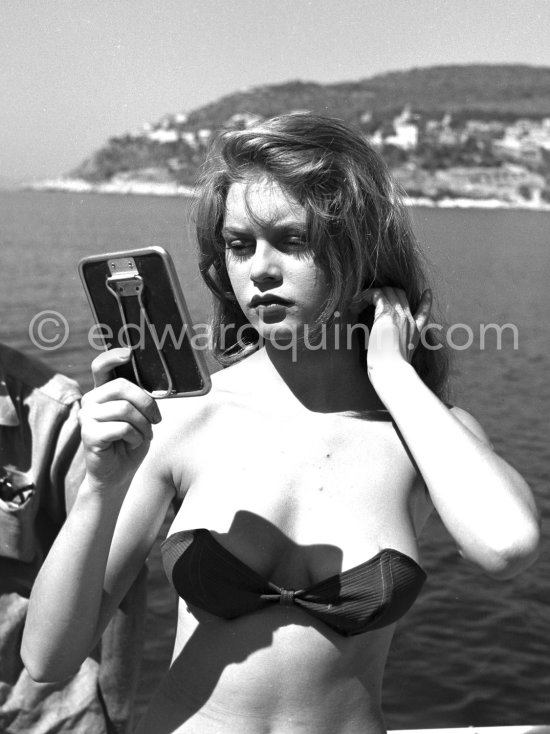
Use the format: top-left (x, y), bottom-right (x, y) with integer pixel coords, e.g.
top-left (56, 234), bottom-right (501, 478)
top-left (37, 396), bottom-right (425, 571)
top-left (0, 0), bottom-right (550, 183)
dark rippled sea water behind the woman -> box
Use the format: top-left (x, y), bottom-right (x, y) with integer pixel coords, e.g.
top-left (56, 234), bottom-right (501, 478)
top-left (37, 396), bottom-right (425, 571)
top-left (0, 191), bottom-right (550, 729)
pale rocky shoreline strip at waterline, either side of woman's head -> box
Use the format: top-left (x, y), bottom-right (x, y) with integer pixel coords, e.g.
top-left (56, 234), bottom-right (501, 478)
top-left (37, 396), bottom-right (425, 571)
top-left (22, 178), bottom-right (550, 212)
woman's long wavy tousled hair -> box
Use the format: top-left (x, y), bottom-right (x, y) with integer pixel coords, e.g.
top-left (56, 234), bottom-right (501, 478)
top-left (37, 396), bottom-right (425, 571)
top-left (196, 113), bottom-right (448, 395)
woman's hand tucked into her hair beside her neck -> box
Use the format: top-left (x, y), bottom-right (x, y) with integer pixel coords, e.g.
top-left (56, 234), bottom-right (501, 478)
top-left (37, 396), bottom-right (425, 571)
top-left (361, 287), bottom-right (432, 377)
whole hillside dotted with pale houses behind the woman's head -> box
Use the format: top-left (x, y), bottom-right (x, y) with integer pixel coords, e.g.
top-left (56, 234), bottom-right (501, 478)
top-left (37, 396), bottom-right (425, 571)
top-left (41, 65), bottom-right (550, 205)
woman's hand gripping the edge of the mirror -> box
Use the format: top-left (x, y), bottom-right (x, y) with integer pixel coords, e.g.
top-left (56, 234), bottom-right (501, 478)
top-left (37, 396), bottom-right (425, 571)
top-left (79, 348), bottom-right (161, 490)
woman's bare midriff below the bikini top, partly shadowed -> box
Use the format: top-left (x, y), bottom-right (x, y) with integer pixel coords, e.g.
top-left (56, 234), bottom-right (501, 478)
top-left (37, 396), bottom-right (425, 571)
top-left (136, 602), bottom-right (393, 734)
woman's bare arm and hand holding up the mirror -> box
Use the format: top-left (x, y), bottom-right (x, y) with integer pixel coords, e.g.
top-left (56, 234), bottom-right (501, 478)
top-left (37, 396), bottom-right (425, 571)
top-left (21, 350), bottom-right (174, 681)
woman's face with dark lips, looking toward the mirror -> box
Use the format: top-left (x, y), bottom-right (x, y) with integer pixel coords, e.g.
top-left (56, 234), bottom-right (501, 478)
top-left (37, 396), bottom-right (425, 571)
top-left (222, 175), bottom-right (329, 343)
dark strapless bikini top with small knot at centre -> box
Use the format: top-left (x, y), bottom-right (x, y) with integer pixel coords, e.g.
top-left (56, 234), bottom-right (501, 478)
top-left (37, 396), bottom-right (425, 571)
top-left (161, 528), bottom-right (426, 636)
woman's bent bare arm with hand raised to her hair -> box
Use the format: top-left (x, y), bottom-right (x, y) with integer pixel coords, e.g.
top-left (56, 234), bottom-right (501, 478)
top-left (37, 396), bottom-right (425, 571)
top-left (368, 288), bottom-right (540, 578)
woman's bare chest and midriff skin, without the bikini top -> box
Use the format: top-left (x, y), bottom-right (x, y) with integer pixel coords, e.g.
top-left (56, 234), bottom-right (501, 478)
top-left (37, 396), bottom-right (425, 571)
top-left (138, 362), bottom-right (429, 734)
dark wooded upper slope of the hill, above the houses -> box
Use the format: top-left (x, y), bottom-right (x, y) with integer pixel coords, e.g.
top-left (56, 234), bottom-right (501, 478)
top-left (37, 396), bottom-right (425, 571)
top-left (180, 65), bottom-right (550, 129)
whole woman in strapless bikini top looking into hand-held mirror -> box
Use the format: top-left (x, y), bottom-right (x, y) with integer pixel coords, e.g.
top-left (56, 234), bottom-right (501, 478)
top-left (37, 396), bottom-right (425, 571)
top-left (23, 114), bottom-right (539, 734)
